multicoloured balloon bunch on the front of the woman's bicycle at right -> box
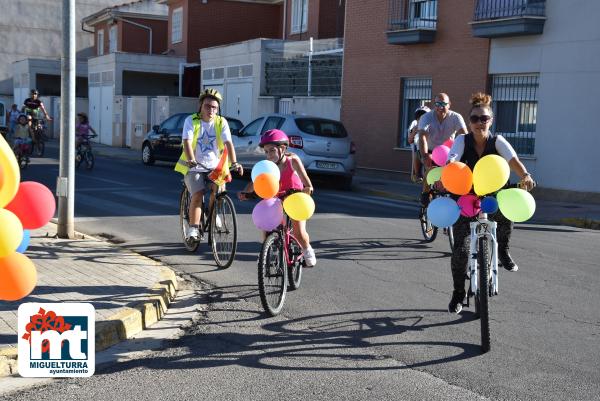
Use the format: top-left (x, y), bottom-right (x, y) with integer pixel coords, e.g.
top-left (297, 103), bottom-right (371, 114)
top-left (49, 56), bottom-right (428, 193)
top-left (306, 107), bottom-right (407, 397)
top-left (427, 155), bottom-right (535, 227)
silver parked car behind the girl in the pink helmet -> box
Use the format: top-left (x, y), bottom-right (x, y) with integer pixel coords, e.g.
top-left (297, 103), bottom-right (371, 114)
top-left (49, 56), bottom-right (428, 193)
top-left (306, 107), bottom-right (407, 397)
top-left (232, 113), bottom-right (356, 189)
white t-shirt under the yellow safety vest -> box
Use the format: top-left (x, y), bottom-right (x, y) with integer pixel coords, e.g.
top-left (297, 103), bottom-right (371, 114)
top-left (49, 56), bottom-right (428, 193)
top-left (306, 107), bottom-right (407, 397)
top-left (181, 116), bottom-right (231, 172)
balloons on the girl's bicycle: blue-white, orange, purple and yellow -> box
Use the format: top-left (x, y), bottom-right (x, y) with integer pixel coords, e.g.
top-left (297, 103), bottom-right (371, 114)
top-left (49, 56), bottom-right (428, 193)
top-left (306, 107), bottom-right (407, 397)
top-left (251, 160), bottom-right (315, 231)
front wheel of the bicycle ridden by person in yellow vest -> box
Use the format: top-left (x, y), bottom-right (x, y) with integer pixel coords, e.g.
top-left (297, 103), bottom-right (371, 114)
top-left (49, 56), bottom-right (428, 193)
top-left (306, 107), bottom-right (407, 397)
top-left (209, 195), bottom-right (237, 269)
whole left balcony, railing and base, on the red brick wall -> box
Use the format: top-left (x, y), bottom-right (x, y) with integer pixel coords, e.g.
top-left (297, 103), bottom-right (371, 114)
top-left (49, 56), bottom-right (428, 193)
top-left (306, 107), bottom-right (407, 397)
top-left (387, 0), bottom-right (438, 44)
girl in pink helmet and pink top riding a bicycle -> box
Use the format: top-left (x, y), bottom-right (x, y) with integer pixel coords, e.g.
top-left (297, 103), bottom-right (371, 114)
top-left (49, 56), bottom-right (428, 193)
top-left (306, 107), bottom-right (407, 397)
top-left (238, 129), bottom-right (317, 267)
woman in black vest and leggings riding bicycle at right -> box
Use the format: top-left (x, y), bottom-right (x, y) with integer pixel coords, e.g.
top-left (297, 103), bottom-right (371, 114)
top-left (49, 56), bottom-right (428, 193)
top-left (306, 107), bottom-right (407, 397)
top-left (437, 93), bottom-right (535, 313)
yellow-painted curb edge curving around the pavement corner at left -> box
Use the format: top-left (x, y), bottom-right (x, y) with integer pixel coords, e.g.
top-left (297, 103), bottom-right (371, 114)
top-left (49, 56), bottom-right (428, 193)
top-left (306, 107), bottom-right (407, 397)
top-left (0, 227), bottom-right (178, 377)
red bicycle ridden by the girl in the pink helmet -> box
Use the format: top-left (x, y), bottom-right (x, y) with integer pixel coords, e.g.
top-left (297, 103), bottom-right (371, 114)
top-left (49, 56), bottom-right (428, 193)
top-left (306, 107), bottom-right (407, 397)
top-left (258, 190), bottom-right (305, 316)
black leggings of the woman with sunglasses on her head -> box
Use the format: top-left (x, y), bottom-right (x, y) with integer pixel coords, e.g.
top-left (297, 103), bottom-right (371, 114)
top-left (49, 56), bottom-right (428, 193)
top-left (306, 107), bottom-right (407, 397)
top-left (450, 211), bottom-right (513, 291)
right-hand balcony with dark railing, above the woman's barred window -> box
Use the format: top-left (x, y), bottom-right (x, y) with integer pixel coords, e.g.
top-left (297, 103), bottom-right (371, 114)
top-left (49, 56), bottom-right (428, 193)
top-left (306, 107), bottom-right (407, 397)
top-left (471, 0), bottom-right (546, 38)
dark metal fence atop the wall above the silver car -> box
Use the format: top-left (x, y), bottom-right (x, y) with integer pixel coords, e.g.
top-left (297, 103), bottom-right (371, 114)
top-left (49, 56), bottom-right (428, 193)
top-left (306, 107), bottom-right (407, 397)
top-left (262, 39), bottom-right (344, 97)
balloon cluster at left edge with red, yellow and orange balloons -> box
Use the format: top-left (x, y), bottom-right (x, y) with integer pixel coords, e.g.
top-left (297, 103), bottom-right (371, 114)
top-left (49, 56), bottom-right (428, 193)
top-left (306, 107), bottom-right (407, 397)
top-left (0, 136), bottom-right (56, 301)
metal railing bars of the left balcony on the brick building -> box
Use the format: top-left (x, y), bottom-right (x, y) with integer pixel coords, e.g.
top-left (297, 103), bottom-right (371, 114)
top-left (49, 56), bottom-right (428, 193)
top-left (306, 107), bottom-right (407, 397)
top-left (388, 0), bottom-right (438, 31)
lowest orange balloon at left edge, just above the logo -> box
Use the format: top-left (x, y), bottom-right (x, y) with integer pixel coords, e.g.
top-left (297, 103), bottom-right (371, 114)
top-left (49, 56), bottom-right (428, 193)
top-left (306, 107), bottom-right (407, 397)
top-left (0, 252), bottom-right (37, 301)
